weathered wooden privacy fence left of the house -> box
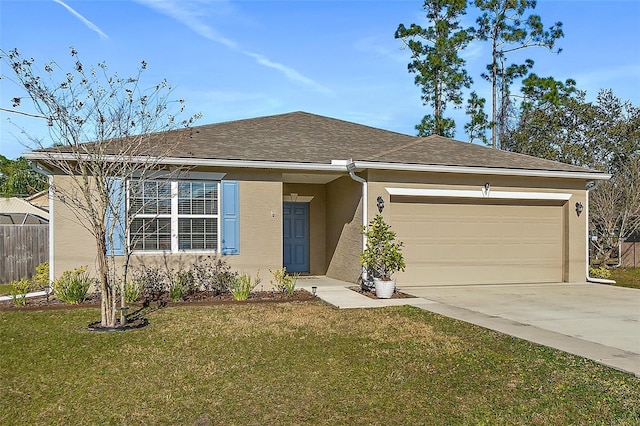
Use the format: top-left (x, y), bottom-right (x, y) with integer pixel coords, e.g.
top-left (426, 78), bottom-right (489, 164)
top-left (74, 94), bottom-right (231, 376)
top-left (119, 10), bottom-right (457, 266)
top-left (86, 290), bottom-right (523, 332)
top-left (0, 225), bottom-right (49, 284)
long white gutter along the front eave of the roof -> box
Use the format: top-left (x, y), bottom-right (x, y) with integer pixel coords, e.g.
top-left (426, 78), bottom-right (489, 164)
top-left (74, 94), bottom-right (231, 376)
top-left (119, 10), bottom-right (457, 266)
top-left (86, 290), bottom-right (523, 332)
top-left (22, 152), bottom-right (611, 180)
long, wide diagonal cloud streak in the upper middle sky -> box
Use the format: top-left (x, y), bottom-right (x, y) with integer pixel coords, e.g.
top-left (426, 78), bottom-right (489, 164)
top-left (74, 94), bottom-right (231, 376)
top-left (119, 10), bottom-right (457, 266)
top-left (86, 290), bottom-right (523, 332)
top-left (135, 0), bottom-right (333, 95)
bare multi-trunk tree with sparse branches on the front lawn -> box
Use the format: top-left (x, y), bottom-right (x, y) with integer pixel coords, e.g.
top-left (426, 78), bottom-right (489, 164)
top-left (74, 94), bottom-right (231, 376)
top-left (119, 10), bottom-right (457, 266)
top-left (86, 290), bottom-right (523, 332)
top-left (0, 48), bottom-right (198, 327)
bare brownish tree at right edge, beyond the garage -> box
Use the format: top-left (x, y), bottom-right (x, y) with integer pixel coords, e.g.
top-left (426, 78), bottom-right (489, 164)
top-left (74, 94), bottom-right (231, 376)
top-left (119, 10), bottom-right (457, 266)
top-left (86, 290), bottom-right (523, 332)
top-left (589, 155), bottom-right (640, 263)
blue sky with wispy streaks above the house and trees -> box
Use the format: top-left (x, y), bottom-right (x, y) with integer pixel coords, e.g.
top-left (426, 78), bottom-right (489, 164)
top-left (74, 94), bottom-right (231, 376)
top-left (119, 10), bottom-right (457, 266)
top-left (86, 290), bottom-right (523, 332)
top-left (0, 0), bottom-right (640, 158)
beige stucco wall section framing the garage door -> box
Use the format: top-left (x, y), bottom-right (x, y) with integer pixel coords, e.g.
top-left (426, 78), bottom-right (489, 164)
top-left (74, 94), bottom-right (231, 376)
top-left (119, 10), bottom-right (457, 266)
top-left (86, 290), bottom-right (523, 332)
top-left (368, 171), bottom-right (586, 282)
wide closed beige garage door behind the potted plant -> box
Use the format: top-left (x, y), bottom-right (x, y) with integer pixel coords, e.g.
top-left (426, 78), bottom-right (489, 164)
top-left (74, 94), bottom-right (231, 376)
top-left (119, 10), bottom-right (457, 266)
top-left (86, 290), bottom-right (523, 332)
top-left (390, 200), bottom-right (563, 287)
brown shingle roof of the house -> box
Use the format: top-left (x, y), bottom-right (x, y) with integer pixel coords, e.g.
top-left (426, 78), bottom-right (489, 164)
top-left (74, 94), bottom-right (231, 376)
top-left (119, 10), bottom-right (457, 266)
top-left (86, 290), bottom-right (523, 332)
top-left (33, 112), bottom-right (596, 173)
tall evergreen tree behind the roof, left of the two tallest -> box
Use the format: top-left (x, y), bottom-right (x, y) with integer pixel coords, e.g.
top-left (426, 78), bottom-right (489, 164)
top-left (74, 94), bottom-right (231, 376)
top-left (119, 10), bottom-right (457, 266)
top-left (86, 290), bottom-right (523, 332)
top-left (395, 0), bottom-right (471, 137)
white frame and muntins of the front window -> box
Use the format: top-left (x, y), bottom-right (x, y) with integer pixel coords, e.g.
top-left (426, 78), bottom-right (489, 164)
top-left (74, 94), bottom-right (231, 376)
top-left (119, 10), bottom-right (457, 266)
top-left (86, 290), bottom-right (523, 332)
top-left (127, 179), bottom-right (222, 255)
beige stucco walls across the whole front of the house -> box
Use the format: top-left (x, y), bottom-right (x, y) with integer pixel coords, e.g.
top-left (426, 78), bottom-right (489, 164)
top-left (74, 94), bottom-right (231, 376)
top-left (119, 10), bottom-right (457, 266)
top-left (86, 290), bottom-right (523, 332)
top-left (52, 168), bottom-right (586, 283)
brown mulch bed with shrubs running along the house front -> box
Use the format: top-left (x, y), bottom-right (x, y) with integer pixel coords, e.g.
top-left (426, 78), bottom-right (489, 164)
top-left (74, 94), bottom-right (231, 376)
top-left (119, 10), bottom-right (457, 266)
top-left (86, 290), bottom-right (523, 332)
top-left (0, 289), bottom-right (318, 311)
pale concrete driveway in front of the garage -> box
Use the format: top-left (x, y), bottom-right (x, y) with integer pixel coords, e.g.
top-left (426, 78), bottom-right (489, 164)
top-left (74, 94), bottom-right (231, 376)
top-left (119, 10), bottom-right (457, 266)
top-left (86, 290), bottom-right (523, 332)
top-left (400, 283), bottom-right (640, 377)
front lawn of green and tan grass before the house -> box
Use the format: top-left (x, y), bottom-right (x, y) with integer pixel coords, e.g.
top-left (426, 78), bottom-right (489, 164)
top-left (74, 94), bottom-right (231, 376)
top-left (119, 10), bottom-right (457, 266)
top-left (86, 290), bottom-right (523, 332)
top-left (0, 303), bottom-right (640, 425)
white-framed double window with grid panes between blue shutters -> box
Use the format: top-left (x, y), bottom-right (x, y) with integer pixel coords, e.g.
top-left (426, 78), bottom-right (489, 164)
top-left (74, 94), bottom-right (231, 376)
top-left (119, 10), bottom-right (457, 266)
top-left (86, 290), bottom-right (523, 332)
top-left (129, 180), bottom-right (219, 252)
